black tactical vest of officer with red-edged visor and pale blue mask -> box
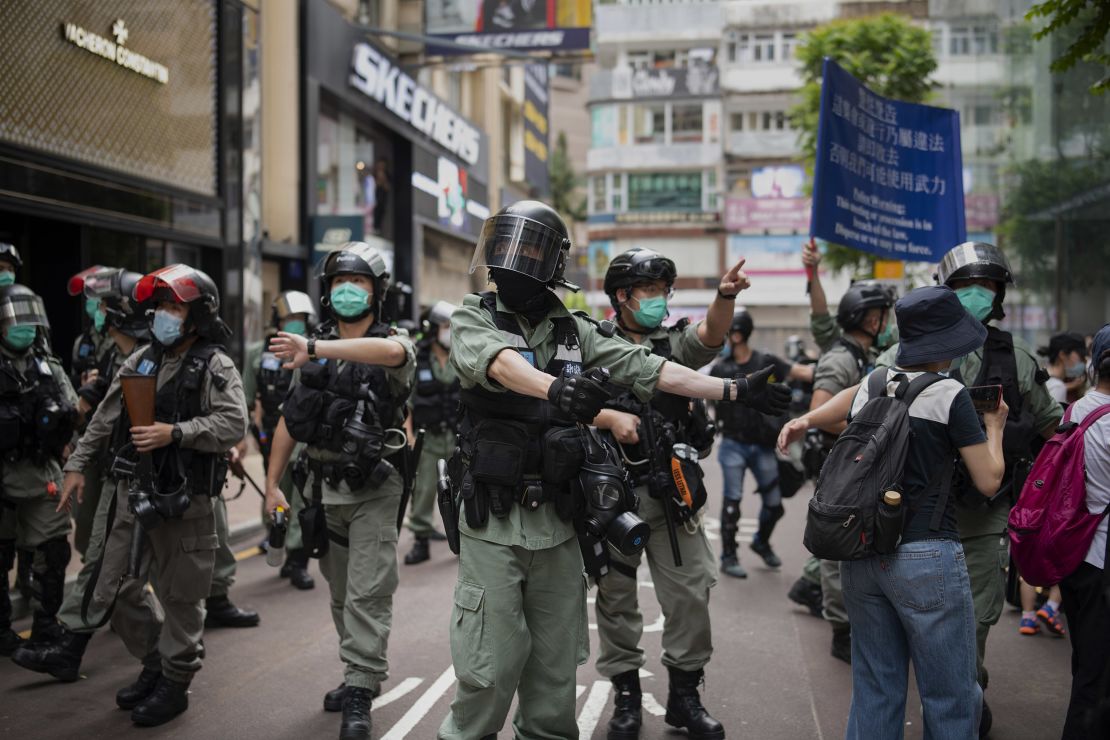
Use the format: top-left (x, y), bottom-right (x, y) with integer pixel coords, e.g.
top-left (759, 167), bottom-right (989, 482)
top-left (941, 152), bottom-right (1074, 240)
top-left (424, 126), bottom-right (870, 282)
top-left (112, 338), bottom-right (228, 496)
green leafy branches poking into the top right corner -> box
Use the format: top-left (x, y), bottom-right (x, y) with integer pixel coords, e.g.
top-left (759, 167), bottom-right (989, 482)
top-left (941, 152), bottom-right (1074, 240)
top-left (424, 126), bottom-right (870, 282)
top-left (1026, 0), bottom-right (1110, 95)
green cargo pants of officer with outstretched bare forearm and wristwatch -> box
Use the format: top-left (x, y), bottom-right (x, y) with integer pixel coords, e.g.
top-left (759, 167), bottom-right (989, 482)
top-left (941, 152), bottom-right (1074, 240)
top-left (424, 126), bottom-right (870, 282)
top-left (320, 487), bottom-right (401, 692)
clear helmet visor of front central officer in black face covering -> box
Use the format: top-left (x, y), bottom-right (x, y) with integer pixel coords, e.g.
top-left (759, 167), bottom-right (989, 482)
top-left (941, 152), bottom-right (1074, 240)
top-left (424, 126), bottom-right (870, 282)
top-left (471, 215), bottom-right (567, 283)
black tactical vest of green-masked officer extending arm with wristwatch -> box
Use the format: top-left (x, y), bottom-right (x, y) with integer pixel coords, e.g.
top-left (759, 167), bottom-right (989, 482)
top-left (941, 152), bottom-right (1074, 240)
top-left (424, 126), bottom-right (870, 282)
top-left (282, 324), bottom-right (400, 459)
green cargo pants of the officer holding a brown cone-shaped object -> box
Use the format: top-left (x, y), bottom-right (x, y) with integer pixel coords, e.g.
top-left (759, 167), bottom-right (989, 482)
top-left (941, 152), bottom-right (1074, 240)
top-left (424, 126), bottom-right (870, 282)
top-left (94, 481), bottom-right (218, 683)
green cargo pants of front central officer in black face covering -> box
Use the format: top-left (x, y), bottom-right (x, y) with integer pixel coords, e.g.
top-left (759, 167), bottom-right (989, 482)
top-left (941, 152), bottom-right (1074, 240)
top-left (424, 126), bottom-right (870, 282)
top-left (437, 535), bottom-right (589, 740)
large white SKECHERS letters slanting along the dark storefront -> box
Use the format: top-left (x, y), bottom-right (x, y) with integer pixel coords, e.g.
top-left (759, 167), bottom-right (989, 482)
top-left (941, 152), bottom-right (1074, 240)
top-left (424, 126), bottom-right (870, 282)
top-left (351, 42), bottom-right (482, 164)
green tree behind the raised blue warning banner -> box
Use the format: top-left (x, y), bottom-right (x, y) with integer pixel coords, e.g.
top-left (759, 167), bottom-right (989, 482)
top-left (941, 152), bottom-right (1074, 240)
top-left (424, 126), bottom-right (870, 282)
top-left (790, 13), bottom-right (937, 275)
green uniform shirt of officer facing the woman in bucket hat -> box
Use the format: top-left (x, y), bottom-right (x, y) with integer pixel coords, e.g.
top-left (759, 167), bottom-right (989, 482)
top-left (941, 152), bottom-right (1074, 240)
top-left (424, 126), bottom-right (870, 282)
top-left (876, 336), bottom-right (1063, 538)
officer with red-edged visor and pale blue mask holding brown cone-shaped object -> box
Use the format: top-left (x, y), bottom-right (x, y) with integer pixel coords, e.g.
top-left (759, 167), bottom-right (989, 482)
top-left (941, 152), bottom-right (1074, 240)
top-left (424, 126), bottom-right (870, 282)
top-left (61, 264), bottom-right (246, 726)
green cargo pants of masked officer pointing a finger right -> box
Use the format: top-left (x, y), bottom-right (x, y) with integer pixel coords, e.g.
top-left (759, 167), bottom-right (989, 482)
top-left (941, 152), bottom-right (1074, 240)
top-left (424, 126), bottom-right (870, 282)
top-left (597, 487), bottom-right (717, 678)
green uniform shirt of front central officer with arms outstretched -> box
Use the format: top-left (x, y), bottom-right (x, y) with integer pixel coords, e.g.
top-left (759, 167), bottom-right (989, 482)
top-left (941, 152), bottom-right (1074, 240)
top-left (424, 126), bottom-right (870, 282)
top-left (451, 294), bottom-right (664, 550)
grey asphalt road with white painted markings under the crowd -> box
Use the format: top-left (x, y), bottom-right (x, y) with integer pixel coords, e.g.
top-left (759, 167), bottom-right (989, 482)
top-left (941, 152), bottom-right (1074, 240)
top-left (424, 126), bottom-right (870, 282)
top-left (0, 458), bottom-right (1070, 740)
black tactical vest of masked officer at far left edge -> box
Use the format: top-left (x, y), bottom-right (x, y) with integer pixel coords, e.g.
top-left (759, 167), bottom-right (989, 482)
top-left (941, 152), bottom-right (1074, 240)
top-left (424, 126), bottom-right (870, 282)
top-left (0, 344), bottom-right (77, 465)
